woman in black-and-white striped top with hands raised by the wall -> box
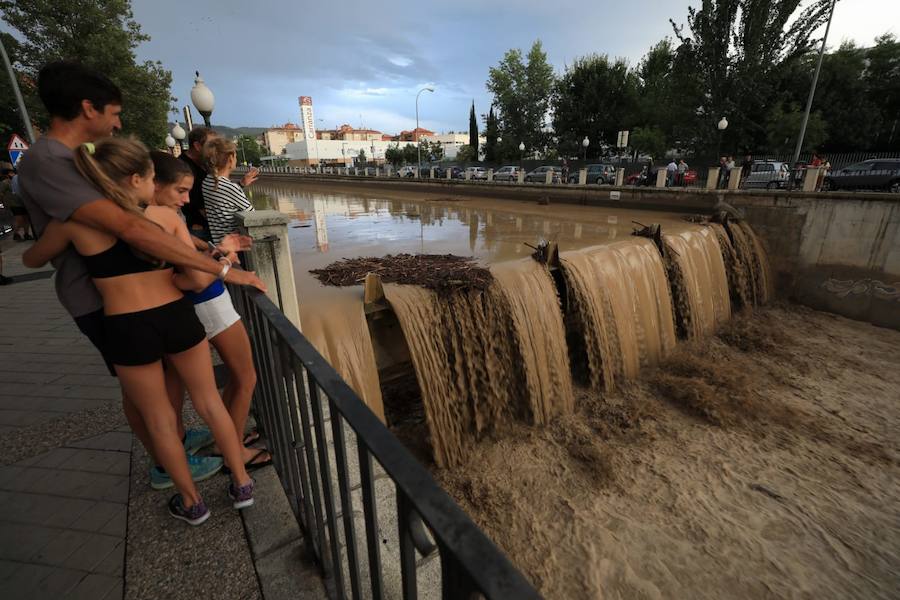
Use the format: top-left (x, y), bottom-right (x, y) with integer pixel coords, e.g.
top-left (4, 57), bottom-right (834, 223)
top-left (203, 137), bottom-right (259, 244)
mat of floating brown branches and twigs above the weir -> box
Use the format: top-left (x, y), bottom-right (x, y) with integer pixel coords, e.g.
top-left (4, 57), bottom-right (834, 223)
top-left (310, 254), bottom-right (493, 292)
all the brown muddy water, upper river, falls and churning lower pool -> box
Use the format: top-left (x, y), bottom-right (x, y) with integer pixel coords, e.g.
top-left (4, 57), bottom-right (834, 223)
top-left (248, 181), bottom-right (900, 598)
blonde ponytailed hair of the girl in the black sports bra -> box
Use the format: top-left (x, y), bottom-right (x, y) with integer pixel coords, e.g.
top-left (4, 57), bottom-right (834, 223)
top-left (75, 137), bottom-right (153, 215)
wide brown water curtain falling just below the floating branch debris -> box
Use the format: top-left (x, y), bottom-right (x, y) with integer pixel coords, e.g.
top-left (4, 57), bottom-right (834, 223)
top-left (385, 259), bottom-right (574, 466)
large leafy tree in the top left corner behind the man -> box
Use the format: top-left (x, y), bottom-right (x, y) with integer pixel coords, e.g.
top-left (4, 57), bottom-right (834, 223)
top-left (0, 0), bottom-right (174, 148)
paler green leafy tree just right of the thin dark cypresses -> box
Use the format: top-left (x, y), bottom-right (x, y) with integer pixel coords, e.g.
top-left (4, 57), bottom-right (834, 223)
top-left (486, 40), bottom-right (555, 157)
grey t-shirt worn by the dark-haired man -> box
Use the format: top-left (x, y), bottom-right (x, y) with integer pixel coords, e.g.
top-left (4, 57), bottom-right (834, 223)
top-left (18, 136), bottom-right (105, 317)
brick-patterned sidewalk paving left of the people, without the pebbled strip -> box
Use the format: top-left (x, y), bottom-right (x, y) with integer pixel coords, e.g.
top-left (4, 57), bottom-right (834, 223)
top-left (0, 242), bottom-right (132, 599)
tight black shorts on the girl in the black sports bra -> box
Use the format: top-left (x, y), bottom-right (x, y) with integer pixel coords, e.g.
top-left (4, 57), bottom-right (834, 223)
top-left (103, 298), bottom-right (206, 367)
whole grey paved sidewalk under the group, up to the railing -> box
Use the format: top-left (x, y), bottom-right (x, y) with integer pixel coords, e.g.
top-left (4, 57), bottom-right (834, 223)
top-left (0, 238), bottom-right (324, 600)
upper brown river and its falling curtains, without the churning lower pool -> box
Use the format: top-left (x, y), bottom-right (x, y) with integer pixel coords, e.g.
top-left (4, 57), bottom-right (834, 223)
top-left (253, 186), bottom-right (771, 466)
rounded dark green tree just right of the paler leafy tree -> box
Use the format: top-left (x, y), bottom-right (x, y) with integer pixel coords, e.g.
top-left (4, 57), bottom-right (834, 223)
top-left (553, 54), bottom-right (638, 156)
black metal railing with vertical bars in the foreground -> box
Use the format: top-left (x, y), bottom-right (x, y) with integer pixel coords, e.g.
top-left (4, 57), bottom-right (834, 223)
top-left (232, 287), bottom-right (540, 600)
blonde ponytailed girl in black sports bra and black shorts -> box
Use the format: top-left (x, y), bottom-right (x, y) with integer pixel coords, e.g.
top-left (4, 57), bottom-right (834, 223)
top-left (23, 138), bottom-right (253, 525)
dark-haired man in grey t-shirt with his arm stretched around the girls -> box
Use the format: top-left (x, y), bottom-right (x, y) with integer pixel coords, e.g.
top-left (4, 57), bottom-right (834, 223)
top-left (19, 62), bottom-right (265, 482)
